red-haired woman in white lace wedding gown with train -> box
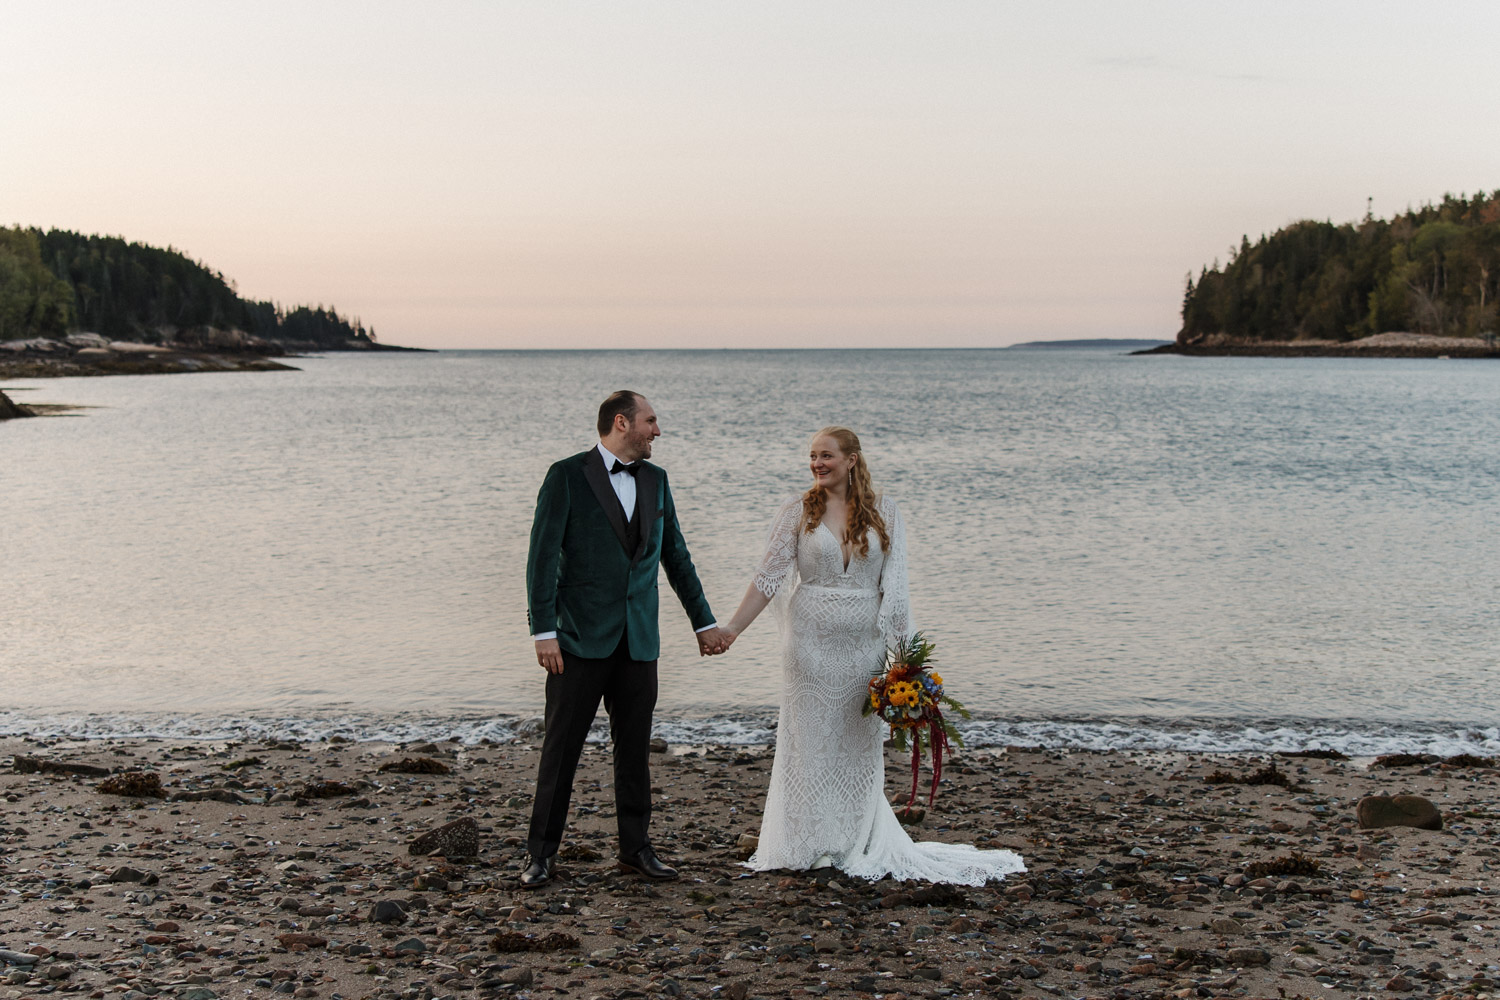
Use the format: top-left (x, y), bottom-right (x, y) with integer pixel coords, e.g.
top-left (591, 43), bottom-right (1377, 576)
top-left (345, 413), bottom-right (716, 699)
top-left (726, 427), bottom-right (1026, 885)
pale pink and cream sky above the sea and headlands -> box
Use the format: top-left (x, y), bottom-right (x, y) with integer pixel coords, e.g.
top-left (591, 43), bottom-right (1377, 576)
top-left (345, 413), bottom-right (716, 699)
top-left (0, 0), bottom-right (1500, 348)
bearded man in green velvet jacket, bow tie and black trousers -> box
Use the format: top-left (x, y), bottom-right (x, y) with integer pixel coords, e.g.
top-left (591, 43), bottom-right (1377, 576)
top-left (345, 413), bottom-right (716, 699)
top-left (521, 391), bottom-right (728, 889)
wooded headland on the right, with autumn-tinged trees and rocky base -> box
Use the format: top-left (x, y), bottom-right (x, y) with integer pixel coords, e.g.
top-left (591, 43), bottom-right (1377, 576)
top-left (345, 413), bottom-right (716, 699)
top-left (1157, 190), bottom-right (1500, 357)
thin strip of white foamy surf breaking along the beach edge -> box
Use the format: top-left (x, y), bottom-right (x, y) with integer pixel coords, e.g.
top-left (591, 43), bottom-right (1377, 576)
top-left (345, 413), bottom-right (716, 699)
top-left (0, 711), bottom-right (1500, 757)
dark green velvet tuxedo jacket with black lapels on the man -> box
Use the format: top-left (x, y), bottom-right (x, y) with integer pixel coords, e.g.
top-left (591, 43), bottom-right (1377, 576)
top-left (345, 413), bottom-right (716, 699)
top-left (527, 448), bottom-right (714, 660)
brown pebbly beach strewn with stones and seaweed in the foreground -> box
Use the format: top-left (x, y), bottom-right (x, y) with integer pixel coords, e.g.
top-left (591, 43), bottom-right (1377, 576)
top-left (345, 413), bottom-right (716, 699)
top-left (0, 736), bottom-right (1500, 1000)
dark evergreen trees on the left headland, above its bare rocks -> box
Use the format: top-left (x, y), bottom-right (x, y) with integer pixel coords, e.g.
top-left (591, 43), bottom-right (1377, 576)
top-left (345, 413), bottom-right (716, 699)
top-left (0, 226), bottom-right (380, 354)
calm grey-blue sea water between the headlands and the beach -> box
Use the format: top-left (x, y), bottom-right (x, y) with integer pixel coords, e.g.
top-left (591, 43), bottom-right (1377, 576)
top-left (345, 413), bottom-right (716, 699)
top-left (0, 351), bottom-right (1500, 753)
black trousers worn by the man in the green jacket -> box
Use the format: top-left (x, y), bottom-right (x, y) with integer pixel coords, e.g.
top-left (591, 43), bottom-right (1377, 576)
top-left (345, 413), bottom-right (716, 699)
top-left (527, 636), bottom-right (657, 858)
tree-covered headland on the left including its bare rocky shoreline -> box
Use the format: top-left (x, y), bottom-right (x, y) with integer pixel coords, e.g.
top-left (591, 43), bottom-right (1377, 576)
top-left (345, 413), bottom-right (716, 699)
top-left (0, 226), bottom-right (417, 378)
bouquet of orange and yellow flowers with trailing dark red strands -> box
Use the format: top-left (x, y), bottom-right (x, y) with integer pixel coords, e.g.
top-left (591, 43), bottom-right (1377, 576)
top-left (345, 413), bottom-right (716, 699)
top-left (863, 633), bottom-right (969, 816)
